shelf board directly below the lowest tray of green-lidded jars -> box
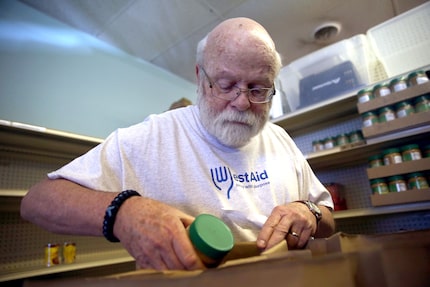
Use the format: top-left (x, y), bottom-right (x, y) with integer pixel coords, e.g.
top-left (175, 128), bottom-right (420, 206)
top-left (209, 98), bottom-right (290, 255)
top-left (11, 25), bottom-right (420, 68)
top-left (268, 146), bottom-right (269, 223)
top-left (333, 201), bottom-right (430, 219)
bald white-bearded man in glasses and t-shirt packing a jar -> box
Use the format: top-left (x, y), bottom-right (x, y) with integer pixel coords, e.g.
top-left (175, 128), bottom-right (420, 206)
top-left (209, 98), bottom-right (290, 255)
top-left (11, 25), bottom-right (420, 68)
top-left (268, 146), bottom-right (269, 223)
top-left (21, 18), bottom-right (335, 270)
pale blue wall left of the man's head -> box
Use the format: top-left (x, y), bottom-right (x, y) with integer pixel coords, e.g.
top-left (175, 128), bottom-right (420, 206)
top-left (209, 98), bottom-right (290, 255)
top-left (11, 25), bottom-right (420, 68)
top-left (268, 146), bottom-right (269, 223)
top-left (0, 1), bottom-right (196, 138)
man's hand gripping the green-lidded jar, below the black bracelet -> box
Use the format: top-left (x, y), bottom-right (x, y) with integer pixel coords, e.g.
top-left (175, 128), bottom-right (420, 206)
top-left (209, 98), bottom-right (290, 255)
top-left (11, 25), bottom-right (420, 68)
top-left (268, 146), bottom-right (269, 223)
top-left (114, 196), bottom-right (204, 270)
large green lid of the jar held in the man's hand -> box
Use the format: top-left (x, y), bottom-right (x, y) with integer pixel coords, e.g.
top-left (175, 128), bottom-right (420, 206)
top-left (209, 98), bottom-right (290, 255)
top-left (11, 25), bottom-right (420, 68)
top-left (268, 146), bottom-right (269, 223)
top-left (189, 214), bottom-right (234, 260)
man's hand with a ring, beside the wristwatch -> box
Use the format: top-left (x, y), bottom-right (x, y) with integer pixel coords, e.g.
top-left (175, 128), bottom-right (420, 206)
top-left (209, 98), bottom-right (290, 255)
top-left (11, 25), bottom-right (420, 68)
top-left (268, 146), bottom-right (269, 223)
top-left (257, 202), bottom-right (317, 252)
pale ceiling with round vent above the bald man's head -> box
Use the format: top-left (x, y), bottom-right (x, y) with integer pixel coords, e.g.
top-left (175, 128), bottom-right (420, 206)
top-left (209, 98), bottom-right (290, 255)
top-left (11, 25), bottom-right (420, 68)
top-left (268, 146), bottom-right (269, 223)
top-left (16, 0), bottom-right (426, 82)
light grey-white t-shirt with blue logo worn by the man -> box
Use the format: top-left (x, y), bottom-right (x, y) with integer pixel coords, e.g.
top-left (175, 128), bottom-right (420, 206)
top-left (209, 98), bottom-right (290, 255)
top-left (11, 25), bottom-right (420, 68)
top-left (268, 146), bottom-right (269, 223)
top-left (48, 106), bottom-right (333, 241)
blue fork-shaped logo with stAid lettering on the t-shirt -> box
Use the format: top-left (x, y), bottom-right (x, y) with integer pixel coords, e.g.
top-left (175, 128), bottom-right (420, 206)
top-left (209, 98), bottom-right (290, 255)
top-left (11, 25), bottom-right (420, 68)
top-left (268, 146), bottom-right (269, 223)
top-left (210, 166), bottom-right (269, 199)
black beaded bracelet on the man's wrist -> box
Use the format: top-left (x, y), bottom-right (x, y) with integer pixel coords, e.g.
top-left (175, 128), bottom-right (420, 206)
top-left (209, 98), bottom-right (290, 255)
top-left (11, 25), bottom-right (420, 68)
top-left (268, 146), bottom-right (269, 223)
top-left (103, 190), bottom-right (140, 242)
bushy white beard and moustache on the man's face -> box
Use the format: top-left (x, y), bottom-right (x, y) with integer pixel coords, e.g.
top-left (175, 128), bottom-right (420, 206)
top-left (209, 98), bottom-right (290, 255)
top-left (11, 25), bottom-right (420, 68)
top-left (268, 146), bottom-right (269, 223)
top-left (198, 95), bottom-right (270, 148)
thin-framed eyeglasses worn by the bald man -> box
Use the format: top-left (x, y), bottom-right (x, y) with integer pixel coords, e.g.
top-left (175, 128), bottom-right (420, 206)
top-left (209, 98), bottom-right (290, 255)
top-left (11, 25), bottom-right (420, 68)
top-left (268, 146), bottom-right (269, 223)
top-left (200, 67), bottom-right (276, 104)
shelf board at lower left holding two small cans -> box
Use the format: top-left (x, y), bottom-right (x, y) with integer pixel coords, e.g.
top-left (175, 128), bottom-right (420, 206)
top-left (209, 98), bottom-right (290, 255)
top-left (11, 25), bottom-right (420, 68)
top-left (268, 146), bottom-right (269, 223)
top-left (0, 249), bottom-right (135, 282)
